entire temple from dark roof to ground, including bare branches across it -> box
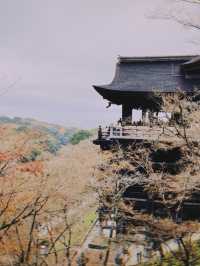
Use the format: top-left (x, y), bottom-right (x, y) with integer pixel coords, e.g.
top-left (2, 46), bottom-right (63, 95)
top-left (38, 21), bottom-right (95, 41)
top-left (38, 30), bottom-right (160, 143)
top-left (82, 55), bottom-right (200, 265)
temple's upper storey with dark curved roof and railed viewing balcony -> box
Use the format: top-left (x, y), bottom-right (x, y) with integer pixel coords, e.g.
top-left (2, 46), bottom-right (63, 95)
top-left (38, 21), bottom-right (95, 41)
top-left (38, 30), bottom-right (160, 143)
top-left (94, 55), bottom-right (200, 149)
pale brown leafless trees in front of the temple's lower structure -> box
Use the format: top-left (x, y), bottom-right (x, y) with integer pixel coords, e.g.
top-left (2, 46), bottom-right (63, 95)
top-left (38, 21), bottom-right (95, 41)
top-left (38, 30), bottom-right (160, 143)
top-left (97, 92), bottom-right (200, 266)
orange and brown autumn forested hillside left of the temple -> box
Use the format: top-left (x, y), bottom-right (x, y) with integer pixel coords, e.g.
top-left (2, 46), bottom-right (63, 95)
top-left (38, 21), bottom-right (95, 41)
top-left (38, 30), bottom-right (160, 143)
top-left (0, 117), bottom-right (99, 266)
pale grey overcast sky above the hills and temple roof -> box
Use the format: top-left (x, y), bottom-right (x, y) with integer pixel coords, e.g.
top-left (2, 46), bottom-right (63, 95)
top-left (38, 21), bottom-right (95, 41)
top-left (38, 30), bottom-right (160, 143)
top-left (0, 0), bottom-right (200, 128)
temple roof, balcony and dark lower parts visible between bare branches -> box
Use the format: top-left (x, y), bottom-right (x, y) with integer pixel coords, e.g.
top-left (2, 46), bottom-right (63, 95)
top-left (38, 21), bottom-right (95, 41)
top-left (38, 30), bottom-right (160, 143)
top-left (94, 56), bottom-right (200, 219)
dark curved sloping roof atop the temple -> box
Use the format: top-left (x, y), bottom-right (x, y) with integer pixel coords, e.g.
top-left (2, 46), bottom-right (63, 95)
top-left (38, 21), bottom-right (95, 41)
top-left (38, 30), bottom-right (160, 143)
top-left (94, 56), bottom-right (200, 98)
